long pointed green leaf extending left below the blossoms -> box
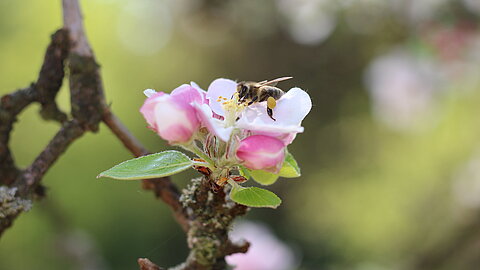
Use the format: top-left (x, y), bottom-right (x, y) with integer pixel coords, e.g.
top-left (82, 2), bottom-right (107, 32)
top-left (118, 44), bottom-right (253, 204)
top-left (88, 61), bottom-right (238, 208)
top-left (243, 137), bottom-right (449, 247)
top-left (97, 150), bottom-right (193, 180)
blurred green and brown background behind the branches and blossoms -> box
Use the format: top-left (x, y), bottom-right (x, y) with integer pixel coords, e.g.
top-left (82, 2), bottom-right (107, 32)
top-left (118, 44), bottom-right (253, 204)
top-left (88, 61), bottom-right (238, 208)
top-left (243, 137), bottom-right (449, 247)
top-left (0, 0), bottom-right (480, 270)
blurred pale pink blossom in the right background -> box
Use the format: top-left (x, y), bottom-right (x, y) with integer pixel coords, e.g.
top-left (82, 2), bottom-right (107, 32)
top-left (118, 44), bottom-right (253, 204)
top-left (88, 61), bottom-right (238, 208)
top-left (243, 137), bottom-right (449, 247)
top-left (366, 49), bottom-right (441, 130)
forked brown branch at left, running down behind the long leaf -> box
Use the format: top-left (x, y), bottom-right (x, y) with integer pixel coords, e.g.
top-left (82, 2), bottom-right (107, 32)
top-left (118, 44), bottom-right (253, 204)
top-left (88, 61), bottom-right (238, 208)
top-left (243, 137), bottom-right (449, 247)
top-left (0, 0), bottom-right (183, 235)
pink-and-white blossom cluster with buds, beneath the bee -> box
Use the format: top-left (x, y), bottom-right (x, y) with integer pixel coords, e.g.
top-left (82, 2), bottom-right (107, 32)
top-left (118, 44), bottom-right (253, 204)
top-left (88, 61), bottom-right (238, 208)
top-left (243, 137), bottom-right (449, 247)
top-left (140, 78), bottom-right (312, 182)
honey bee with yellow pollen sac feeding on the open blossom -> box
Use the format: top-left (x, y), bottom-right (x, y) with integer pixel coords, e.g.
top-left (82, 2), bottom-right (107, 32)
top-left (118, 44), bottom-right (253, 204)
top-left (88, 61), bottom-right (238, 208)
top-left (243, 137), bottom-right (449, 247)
top-left (237, 77), bottom-right (293, 121)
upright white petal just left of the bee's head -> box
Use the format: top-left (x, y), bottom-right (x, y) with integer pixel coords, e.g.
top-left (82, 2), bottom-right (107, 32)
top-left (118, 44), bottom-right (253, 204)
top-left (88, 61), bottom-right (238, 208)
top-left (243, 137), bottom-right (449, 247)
top-left (207, 79), bottom-right (237, 116)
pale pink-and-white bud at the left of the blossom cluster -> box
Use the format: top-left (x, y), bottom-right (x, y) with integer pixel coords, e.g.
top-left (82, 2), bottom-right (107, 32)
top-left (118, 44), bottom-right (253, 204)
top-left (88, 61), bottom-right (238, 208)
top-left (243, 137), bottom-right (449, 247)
top-left (140, 86), bottom-right (200, 144)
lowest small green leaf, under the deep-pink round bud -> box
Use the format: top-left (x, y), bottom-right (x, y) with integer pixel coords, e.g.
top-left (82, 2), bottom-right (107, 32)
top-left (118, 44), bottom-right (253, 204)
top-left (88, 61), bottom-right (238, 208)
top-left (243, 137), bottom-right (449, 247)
top-left (230, 183), bottom-right (282, 208)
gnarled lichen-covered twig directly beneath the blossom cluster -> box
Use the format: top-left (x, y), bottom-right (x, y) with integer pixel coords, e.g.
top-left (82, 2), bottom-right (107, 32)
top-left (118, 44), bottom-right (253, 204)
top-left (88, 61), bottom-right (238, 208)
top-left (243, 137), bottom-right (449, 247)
top-left (178, 177), bottom-right (248, 270)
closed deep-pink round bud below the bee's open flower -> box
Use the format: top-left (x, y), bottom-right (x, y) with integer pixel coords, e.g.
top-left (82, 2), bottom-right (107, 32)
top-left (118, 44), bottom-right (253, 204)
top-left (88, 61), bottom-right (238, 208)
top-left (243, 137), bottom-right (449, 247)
top-left (237, 135), bottom-right (285, 173)
